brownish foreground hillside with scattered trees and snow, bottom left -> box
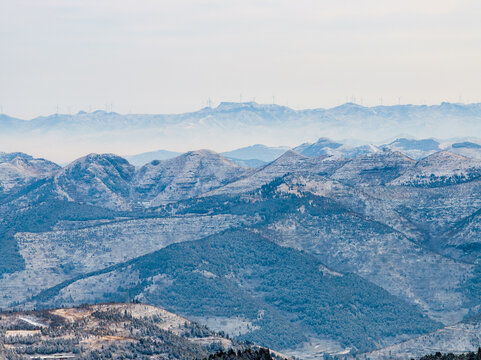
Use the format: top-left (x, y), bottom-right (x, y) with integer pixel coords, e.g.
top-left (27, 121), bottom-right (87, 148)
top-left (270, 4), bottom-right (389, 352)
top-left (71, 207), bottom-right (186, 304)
top-left (0, 303), bottom-right (240, 360)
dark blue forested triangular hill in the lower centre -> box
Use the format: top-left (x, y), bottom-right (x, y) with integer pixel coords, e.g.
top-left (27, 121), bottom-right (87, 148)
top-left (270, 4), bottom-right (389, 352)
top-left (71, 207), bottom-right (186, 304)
top-left (28, 231), bottom-right (439, 356)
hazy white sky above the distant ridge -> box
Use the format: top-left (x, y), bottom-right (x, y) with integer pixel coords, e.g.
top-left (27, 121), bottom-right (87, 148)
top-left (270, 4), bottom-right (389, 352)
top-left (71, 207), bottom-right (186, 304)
top-left (0, 0), bottom-right (481, 118)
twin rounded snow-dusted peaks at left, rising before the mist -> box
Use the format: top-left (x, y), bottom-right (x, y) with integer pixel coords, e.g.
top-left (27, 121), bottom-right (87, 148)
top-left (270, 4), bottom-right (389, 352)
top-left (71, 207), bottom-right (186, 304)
top-left (5, 150), bottom-right (247, 210)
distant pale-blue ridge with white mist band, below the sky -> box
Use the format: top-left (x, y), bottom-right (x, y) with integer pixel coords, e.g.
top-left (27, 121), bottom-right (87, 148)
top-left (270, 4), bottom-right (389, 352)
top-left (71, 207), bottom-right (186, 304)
top-left (0, 102), bottom-right (481, 165)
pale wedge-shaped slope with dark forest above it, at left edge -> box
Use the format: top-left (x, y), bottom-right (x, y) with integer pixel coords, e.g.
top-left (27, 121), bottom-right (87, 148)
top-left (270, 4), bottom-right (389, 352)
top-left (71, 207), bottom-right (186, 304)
top-left (0, 201), bottom-right (249, 308)
